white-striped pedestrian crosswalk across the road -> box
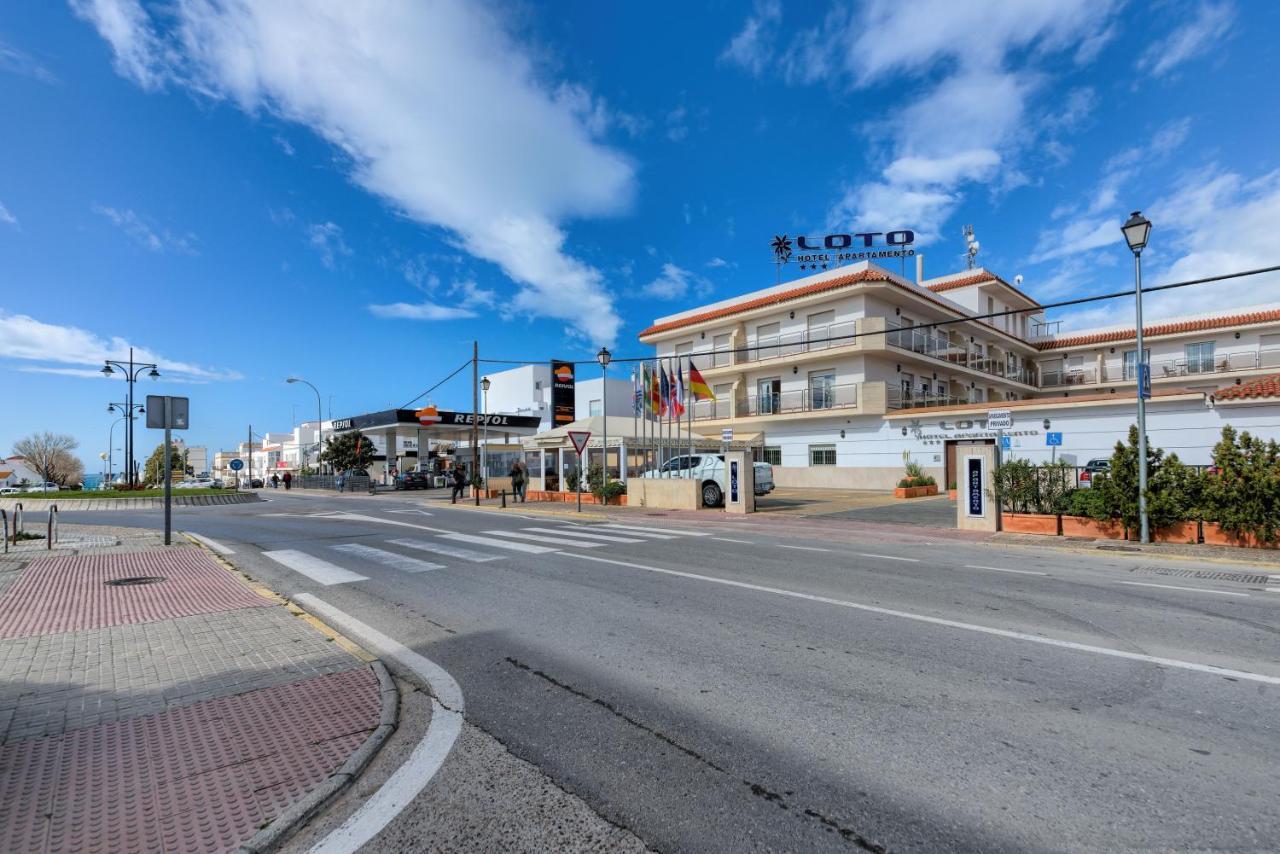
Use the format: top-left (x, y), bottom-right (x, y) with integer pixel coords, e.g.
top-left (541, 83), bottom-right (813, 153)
top-left (264, 525), bottom-right (709, 585)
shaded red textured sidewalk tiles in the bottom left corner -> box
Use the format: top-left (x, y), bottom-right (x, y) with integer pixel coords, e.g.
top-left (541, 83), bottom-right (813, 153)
top-left (0, 667), bottom-right (379, 853)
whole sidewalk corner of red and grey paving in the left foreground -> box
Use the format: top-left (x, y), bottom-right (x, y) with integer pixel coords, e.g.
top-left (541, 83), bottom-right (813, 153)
top-left (0, 529), bottom-right (380, 853)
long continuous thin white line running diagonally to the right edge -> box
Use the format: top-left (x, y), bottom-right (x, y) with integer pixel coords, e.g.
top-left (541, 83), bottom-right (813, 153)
top-left (562, 552), bottom-right (1280, 685)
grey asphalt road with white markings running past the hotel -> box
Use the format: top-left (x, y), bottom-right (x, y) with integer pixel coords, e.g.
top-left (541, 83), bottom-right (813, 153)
top-left (63, 493), bottom-right (1280, 851)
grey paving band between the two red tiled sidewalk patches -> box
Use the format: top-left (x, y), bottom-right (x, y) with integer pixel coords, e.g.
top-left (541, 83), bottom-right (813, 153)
top-left (0, 606), bottom-right (357, 743)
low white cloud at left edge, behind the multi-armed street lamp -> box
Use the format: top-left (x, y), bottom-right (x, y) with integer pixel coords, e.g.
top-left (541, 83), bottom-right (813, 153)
top-left (0, 310), bottom-right (243, 380)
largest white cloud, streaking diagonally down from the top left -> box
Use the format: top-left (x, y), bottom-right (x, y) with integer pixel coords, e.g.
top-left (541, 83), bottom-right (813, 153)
top-left (77, 0), bottom-right (635, 343)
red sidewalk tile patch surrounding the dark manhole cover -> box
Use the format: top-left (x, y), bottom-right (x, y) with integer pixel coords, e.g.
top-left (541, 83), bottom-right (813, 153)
top-left (0, 549), bottom-right (271, 638)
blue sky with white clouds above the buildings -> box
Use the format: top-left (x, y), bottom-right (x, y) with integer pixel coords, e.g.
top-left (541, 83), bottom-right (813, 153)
top-left (0, 0), bottom-right (1280, 470)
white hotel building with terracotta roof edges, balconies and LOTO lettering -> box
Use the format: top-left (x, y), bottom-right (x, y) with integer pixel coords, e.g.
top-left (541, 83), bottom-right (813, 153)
top-left (640, 262), bottom-right (1280, 489)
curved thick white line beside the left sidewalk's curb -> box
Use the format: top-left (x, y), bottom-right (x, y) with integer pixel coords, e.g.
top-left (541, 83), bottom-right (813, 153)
top-left (293, 593), bottom-right (465, 854)
